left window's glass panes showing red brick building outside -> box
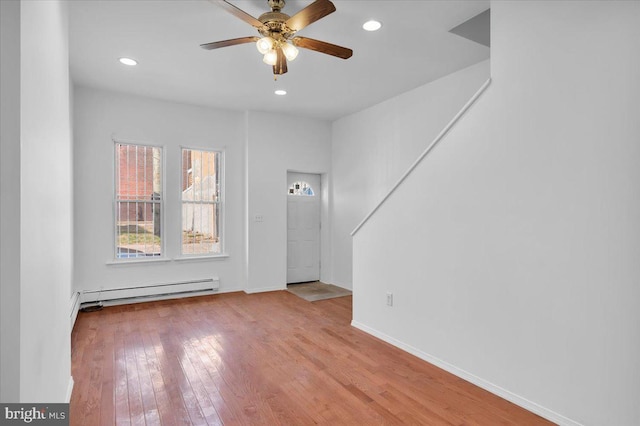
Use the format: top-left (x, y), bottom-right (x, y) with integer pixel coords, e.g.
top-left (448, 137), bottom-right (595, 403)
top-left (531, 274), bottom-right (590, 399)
top-left (115, 143), bottom-right (163, 259)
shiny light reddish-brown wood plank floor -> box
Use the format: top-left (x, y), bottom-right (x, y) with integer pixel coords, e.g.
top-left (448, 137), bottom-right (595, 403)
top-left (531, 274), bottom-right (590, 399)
top-left (70, 291), bottom-right (550, 426)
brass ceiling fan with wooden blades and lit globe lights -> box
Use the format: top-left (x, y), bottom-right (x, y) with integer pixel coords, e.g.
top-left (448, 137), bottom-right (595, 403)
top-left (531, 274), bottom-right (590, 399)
top-left (200, 0), bottom-right (353, 77)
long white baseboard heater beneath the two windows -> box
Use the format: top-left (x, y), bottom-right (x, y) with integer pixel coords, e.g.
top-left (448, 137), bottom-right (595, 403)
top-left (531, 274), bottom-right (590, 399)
top-left (82, 277), bottom-right (220, 305)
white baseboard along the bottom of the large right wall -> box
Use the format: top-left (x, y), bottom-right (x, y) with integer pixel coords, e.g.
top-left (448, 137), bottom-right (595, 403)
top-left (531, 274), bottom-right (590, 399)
top-left (351, 321), bottom-right (583, 426)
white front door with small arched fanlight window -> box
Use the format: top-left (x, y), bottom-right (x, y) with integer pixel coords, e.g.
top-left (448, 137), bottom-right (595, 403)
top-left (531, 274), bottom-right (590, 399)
top-left (287, 173), bottom-right (320, 284)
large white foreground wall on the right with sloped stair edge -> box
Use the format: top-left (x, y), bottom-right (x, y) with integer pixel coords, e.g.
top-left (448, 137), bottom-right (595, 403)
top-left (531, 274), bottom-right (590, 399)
top-left (350, 1), bottom-right (640, 425)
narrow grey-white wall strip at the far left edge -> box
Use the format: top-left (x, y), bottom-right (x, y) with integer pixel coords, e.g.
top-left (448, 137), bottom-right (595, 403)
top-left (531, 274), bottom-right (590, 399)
top-left (0, 1), bottom-right (20, 402)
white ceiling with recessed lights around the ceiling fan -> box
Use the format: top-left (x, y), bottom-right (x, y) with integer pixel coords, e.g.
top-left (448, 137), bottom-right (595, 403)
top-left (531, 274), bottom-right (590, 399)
top-left (69, 0), bottom-right (489, 120)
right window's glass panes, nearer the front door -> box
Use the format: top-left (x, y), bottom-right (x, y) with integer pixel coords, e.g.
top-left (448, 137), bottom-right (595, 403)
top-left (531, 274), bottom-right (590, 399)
top-left (182, 149), bottom-right (222, 255)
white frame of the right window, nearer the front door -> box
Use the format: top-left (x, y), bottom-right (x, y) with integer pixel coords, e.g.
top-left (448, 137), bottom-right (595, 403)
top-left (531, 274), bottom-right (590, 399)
top-left (177, 146), bottom-right (228, 260)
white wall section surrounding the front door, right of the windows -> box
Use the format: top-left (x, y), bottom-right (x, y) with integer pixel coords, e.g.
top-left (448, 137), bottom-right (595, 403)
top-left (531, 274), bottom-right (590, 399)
top-left (246, 112), bottom-right (331, 292)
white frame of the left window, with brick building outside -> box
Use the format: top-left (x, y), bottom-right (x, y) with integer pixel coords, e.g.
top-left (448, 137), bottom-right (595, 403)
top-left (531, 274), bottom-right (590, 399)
top-left (114, 138), bottom-right (168, 263)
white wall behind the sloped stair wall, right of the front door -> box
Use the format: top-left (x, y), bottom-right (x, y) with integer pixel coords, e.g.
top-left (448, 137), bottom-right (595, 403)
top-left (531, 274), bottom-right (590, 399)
top-left (330, 61), bottom-right (489, 288)
